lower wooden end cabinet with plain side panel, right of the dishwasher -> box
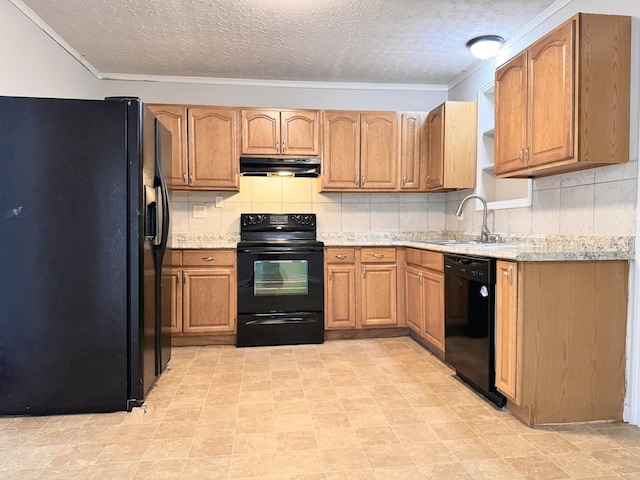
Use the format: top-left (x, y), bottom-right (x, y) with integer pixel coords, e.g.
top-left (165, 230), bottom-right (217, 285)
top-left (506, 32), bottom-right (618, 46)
top-left (496, 261), bottom-right (629, 425)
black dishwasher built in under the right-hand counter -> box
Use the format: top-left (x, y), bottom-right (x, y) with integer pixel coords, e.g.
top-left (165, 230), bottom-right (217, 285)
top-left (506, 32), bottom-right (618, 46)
top-left (444, 254), bottom-right (506, 407)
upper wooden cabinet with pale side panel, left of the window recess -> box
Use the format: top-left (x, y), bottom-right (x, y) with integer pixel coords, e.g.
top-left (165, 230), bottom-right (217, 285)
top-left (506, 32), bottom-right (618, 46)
top-left (423, 102), bottom-right (478, 191)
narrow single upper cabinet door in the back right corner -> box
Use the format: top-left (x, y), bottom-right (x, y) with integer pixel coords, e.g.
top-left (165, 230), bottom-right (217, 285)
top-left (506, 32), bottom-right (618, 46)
top-left (400, 113), bottom-right (422, 190)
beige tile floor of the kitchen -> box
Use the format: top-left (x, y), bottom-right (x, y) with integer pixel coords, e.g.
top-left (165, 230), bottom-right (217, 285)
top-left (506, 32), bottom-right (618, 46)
top-left (0, 337), bottom-right (640, 480)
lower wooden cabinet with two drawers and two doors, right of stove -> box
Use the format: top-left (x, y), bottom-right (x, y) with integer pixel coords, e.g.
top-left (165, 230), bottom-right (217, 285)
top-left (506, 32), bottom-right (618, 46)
top-left (325, 247), bottom-right (399, 330)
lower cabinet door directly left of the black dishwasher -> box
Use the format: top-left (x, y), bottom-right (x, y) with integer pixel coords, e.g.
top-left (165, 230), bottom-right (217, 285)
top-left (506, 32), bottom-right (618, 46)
top-left (421, 270), bottom-right (444, 352)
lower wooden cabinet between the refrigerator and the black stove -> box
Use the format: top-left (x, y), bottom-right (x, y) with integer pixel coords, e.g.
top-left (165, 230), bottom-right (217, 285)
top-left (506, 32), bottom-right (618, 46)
top-left (172, 250), bottom-right (236, 343)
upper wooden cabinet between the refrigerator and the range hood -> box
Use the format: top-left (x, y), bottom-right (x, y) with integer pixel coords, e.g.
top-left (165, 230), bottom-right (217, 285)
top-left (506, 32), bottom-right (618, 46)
top-left (147, 105), bottom-right (240, 190)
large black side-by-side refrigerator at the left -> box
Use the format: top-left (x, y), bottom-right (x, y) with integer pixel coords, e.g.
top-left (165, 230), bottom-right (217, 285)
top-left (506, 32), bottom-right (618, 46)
top-left (0, 97), bottom-right (171, 415)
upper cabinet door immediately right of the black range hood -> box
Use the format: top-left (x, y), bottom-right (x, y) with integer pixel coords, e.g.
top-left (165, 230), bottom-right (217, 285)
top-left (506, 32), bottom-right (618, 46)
top-left (321, 111), bottom-right (360, 190)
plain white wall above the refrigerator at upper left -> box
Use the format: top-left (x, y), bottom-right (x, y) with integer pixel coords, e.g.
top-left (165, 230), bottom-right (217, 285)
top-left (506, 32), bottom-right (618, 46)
top-left (0, 0), bottom-right (100, 99)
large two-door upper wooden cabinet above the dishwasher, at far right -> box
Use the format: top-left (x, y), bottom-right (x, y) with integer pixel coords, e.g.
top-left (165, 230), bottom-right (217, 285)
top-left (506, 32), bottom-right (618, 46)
top-left (494, 14), bottom-right (631, 177)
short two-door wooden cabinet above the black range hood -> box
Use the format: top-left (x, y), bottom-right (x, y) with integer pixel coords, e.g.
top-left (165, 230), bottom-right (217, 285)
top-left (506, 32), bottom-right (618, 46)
top-left (242, 109), bottom-right (320, 157)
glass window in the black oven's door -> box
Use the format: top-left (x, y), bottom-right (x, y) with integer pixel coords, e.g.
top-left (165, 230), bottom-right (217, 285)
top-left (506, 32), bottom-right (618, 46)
top-left (253, 260), bottom-right (309, 297)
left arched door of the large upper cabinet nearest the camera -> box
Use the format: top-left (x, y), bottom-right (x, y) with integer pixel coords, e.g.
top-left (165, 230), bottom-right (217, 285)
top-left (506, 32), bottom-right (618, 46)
top-left (494, 52), bottom-right (527, 175)
